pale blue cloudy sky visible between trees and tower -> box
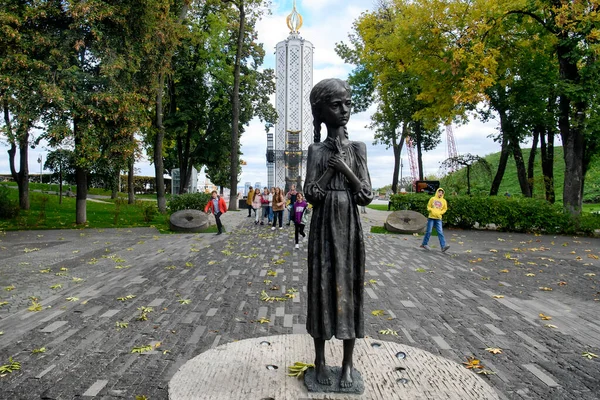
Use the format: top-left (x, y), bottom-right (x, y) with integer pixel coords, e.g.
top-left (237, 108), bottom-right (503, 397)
top-left (0, 0), bottom-right (516, 189)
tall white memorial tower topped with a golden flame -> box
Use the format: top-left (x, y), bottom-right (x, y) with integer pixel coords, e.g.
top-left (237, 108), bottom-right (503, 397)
top-left (267, 0), bottom-right (314, 191)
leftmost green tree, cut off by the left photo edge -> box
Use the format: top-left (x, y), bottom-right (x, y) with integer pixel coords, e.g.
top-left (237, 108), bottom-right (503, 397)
top-left (0, 0), bottom-right (57, 210)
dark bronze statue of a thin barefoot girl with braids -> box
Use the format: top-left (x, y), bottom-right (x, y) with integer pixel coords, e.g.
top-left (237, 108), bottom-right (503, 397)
top-left (304, 79), bottom-right (373, 388)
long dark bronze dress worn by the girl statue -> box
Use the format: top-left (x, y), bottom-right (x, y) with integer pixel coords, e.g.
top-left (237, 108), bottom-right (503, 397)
top-left (305, 139), bottom-right (373, 340)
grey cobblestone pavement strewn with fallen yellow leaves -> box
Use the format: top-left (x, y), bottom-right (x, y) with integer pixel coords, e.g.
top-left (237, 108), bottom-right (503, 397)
top-left (0, 210), bottom-right (600, 400)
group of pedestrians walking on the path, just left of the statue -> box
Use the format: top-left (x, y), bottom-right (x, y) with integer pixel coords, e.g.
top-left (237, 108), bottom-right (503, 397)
top-left (246, 185), bottom-right (308, 248)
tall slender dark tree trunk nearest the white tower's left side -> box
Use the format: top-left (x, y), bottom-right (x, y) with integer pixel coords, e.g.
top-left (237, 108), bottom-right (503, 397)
top-left (229, 0), bottom-right (246, 210)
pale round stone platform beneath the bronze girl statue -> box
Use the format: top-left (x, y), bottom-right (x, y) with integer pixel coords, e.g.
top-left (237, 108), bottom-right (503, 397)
top-left (169, 335), bottom-right (498, 400)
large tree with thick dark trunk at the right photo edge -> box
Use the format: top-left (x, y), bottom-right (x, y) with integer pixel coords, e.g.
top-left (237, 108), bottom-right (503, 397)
top-left (505, 0), bottom-right (600, 214)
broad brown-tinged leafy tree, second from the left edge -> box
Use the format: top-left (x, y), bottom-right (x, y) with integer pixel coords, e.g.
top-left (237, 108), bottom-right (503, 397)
top-left (39, 1), bottom-right (156, 224)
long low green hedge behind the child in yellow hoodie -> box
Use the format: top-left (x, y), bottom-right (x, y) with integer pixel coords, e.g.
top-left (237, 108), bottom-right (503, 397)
top-left (391, 194), bottom-right (600, 235)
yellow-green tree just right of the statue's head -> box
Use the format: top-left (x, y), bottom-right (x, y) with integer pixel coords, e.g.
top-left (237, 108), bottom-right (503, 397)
top-left (336, 1), bottom-right (440, 192)
